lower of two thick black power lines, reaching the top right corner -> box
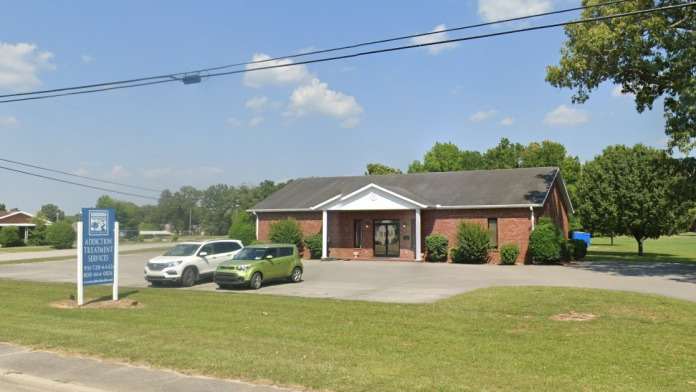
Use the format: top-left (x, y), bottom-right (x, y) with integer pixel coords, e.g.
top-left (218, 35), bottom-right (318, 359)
top-left (0, 2), bottom-right (696, 103)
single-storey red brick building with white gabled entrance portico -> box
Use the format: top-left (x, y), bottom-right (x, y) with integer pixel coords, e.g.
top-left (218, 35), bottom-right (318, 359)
top-left (250, 167), bottom-right (573, 263)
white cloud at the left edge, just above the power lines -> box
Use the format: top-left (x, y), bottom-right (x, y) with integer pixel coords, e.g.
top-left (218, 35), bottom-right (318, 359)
top-left (0, 42), bottom-right (55, 91)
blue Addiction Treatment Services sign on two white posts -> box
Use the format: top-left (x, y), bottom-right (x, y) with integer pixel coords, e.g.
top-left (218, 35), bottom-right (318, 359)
top-left (77, 208), bottom-right (119, 306)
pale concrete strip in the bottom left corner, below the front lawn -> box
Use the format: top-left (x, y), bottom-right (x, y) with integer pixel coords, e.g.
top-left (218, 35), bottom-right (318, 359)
top-left (0, 343), bottom-right (290, 392)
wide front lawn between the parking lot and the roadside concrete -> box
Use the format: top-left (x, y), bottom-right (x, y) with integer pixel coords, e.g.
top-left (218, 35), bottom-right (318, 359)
top-left (0, 280), bottom-right (696, 391)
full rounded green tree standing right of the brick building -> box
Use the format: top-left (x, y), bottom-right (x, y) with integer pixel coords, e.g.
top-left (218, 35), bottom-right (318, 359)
top-left (578, 144), bottom-right (692, 256)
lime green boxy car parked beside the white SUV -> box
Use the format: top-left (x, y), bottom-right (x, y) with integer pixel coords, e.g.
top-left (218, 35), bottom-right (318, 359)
top-left (214, 244), bottom-right (304, 290)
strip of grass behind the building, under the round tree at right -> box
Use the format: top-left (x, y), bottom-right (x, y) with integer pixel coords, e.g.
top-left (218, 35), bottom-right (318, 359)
top-left (585, 233), bottom-right (696, 263)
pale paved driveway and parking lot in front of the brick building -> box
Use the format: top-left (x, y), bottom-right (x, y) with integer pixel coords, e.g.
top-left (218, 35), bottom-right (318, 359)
top-left (0, 252), bottom-right (696, 303)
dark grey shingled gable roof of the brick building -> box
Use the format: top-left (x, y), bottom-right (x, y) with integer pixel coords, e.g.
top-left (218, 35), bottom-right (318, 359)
top-left (251, 167), bottom-right (572, 211)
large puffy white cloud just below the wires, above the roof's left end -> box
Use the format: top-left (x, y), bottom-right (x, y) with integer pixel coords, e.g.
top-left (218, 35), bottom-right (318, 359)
top-left (287, 78), bottom-right (363, 128)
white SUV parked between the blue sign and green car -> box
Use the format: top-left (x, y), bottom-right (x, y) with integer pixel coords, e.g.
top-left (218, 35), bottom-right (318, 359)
top-left (145, 240), bottom-right (244, 287)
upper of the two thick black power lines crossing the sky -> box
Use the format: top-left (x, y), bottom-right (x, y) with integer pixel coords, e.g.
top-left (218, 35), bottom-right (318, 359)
top-left (0, 0), bottom-right (631, 98)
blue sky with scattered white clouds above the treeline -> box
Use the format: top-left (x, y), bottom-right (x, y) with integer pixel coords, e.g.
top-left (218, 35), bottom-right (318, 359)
top-left (0, 0), bottom-right (664, 213)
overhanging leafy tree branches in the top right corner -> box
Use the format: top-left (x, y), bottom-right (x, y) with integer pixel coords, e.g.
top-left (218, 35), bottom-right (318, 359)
top-left (546, 0), bottom-right (696, 153)
